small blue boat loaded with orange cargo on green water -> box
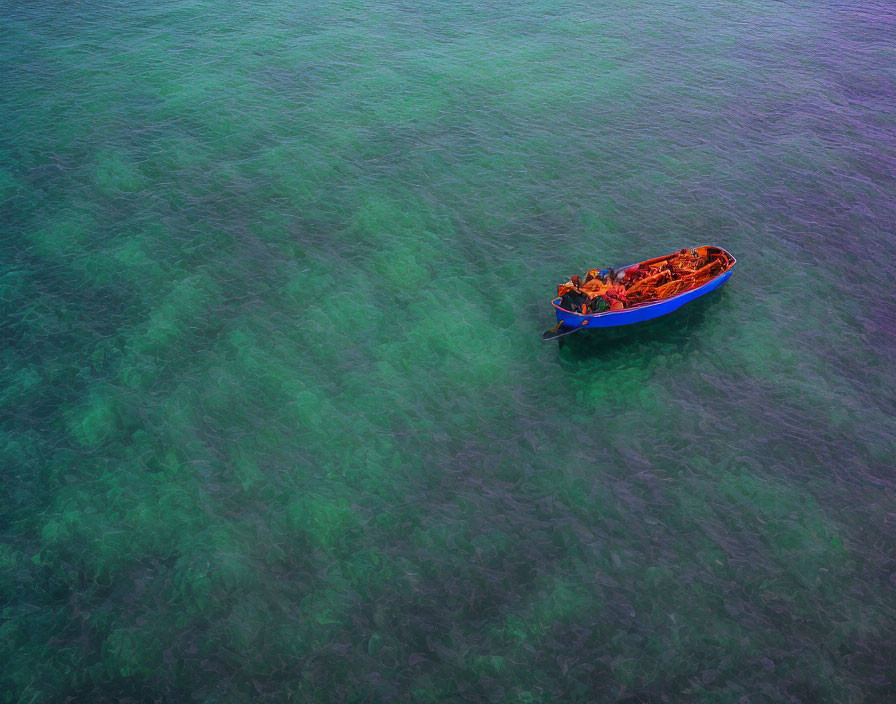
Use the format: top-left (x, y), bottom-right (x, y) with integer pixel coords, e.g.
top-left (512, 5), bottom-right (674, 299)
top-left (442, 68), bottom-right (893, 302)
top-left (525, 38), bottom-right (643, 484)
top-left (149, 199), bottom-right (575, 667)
top-left (542, 245), bottom-right (737, 340)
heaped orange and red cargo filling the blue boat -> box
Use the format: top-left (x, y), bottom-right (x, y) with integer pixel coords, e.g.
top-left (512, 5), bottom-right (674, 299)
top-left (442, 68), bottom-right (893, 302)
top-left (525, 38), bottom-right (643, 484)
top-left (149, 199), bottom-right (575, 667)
top-left (557, 247), bottom-right (731, 313)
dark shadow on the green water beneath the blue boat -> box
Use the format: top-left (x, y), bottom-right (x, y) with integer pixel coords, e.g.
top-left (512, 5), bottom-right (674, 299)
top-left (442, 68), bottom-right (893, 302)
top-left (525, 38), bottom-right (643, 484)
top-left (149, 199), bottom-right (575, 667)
top-left (557, 291), bottom-right (727, 361)
